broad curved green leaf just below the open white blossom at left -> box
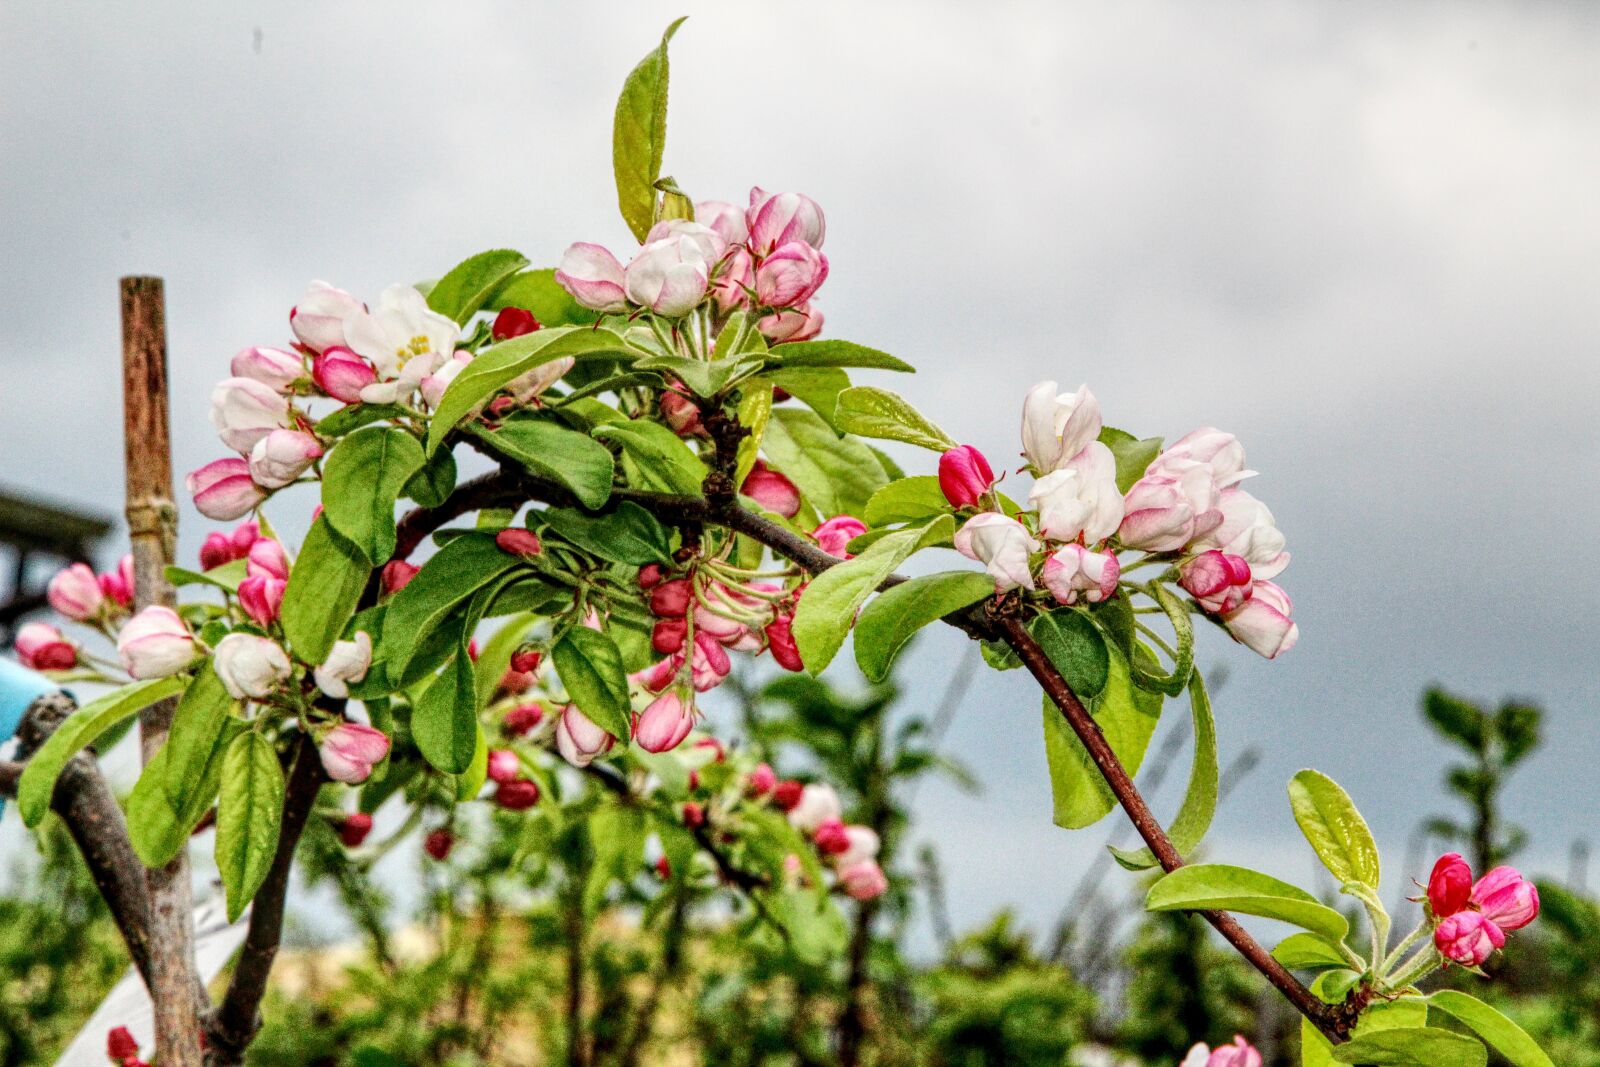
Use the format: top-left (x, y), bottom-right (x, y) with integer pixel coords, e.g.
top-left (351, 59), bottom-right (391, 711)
top-left (322, 426), bottom-right (422, 566)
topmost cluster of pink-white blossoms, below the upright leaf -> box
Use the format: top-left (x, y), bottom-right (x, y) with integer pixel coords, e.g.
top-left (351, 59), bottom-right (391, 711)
top-left (555, 187), bottom-right (827, 344)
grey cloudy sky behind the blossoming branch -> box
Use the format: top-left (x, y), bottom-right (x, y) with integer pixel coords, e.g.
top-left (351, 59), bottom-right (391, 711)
top-left (0, 0), bottom-right (1600, 953)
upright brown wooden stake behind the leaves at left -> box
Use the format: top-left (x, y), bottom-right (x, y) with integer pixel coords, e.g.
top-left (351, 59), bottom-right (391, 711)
top-left (122, 277), bottom-right (202, 1067)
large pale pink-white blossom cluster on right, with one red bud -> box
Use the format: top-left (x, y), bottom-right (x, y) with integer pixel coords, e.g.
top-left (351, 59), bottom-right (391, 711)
top-left (939, 382), bottom-right (1299, 659)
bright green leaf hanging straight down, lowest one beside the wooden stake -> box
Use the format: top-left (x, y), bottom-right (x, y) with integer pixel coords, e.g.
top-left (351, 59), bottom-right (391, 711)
top-left (216, 731), bottom-right (283, 923)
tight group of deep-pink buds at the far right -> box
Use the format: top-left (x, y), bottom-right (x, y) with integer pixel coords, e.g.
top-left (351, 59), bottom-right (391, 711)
top-left (1427, 853), bottom-right (1539, 966)
